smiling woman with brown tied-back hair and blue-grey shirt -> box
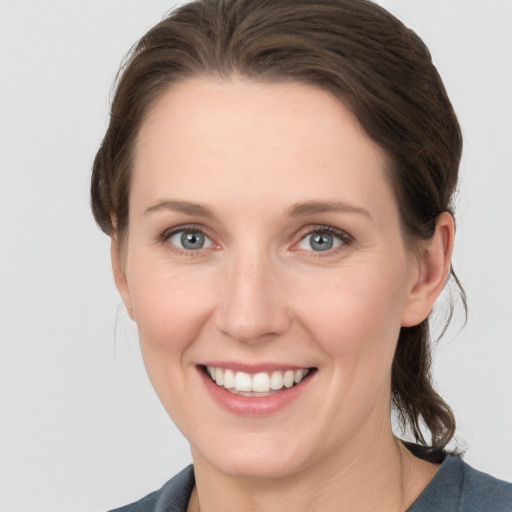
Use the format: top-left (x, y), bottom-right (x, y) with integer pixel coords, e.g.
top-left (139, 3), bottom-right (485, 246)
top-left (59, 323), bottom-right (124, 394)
top-left (92, 0), bottom-right (512, 512)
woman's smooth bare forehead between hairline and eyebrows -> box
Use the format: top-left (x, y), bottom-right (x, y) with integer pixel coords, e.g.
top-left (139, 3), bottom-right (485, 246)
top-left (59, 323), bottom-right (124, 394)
top-left (132, 77), bottom-right (396, 224)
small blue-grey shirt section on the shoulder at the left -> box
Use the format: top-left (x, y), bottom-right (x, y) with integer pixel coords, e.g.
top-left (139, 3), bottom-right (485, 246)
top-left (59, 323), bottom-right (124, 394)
top-left (110, 465), bottom-right (195, 512)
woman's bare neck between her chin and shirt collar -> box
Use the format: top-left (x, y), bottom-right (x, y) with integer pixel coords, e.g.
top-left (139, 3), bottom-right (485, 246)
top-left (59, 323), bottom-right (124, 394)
top-left (188, 429), bottom-right (437, 512)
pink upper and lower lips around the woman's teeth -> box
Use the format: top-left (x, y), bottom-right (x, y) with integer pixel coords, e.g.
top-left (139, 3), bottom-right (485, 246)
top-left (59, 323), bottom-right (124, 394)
top-left (197, 362), bottom-right (316, 417)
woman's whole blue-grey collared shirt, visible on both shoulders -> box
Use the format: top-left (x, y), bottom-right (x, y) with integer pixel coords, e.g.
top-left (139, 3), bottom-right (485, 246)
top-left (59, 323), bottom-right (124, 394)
top-left (111, 455), bottom-right (512, 512)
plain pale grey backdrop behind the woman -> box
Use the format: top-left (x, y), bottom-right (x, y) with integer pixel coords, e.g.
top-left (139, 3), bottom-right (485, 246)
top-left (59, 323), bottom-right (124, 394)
top-left (0, 0), bottom-right (512, 512)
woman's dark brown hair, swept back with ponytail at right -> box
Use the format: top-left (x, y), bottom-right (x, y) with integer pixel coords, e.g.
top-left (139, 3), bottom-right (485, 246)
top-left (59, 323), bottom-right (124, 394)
top-left (91, 0), bottom-right (464, 461)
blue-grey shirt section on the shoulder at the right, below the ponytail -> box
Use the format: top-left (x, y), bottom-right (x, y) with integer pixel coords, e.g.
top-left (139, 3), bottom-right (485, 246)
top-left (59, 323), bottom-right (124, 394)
top-left (409, 456), bottom-right (512, 512)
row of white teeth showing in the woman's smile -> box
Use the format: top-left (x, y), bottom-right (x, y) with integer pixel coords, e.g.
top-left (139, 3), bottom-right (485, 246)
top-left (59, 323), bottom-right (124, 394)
top-left (206, 366), bottom-right (309, 393)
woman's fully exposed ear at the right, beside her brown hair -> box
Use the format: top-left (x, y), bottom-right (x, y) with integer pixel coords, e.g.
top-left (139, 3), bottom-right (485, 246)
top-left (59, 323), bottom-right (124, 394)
top-left (401, 212), bottom-right (455, 327)
